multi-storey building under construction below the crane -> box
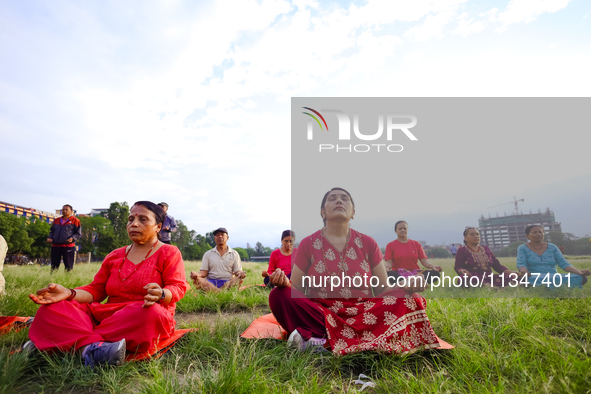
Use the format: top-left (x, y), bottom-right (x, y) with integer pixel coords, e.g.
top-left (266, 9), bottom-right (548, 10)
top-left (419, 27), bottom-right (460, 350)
top-left (478, 208), bottom-right (562, 251)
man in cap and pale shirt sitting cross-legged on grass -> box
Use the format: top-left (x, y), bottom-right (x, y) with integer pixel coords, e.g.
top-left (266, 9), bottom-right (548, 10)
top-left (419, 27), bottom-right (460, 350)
top-left (191, 227), bottom-right (246, 291)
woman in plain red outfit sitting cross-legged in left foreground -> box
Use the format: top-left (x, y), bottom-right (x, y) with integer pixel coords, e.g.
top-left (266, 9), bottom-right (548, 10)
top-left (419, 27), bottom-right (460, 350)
top-left (26, 201), bottom-right (186, 367)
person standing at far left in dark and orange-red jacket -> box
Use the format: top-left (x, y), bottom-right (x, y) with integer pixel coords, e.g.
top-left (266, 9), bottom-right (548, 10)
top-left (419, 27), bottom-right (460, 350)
top-left (47, 204), bottom-right (82, 272)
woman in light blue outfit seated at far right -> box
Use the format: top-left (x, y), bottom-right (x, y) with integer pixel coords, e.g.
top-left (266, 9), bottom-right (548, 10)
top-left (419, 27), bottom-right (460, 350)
top-left (517, 225), bottom-right (591, 288)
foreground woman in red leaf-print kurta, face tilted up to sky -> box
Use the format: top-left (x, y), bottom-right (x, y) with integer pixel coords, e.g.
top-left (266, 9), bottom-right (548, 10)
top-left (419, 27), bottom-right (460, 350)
top-left (269, 188), bottom-right (439, 355)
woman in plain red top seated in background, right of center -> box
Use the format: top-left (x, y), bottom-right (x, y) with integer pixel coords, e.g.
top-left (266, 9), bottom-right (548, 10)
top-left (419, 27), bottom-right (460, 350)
top-left (384, 220), bottom-right (441, 283)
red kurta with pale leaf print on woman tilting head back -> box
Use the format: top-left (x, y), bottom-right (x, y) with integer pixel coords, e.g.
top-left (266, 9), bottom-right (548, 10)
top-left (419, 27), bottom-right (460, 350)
top-left (278, 229), bottom-right (439, 355)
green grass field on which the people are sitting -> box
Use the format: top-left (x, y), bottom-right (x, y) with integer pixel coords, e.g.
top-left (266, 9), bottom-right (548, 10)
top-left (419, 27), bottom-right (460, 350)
top-left (0, 256), bottom-right (591, 393)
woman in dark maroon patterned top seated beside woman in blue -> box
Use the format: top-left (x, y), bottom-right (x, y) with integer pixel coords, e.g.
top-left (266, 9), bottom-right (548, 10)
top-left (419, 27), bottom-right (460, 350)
top-left (455, 227), bottom-right (519, 287)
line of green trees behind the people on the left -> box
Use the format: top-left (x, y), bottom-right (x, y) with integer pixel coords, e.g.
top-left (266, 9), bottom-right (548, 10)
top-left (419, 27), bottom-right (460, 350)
top-left (0, 202), bottom-right (273, 261)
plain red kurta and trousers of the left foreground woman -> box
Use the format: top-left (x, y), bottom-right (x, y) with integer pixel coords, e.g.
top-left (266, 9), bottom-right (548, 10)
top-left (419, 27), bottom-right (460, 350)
top-left (29, 244), bottom-right (186, 352)
